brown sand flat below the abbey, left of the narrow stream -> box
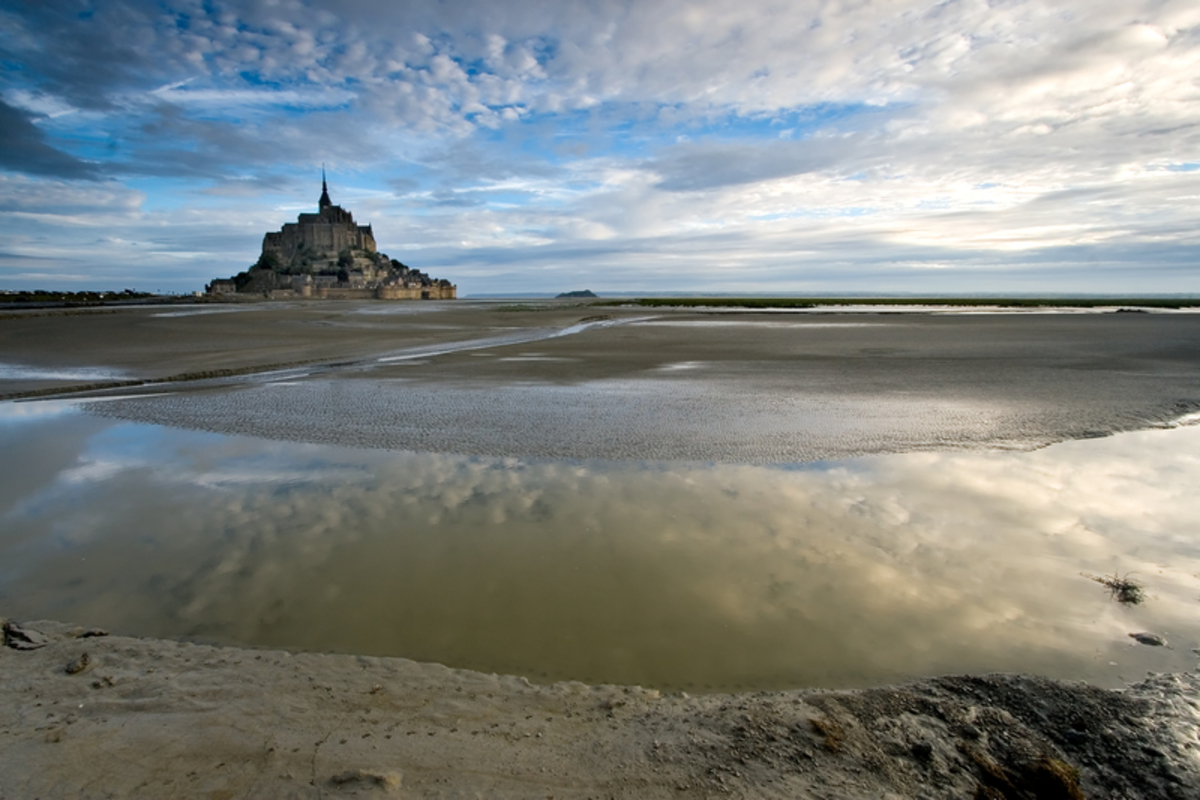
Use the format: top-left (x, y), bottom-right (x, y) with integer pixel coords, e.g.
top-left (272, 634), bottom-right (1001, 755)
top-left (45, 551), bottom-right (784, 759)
top-left (0, 302), bottom-right (537, 396)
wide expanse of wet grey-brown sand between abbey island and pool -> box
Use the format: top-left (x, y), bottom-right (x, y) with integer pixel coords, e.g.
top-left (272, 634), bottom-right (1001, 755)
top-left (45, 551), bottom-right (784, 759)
top-left (0, 302), bottom-right (1200, 463)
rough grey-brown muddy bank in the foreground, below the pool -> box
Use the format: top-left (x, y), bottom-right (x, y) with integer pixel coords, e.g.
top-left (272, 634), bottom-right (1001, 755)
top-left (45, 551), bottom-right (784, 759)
top-left (0, 621), bottom-right (1200, 800)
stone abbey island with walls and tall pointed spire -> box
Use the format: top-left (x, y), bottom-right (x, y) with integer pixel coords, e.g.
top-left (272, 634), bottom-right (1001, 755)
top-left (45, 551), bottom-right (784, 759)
top-left (206, 170), bottom-right (457, 300)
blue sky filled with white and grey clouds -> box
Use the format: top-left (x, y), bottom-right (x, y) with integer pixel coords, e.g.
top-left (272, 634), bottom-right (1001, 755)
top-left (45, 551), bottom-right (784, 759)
top-left (0, 0), bottom-right (1200, 296)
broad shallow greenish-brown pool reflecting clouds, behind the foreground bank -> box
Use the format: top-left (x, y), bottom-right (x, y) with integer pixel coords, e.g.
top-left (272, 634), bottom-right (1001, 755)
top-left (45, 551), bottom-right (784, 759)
top-left (0, 404), bottom-right (1200, 690)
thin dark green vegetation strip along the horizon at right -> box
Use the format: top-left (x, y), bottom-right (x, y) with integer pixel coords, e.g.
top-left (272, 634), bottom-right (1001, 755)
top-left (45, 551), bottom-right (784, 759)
top-left (604, 297), bottom-right (1200, 308)
